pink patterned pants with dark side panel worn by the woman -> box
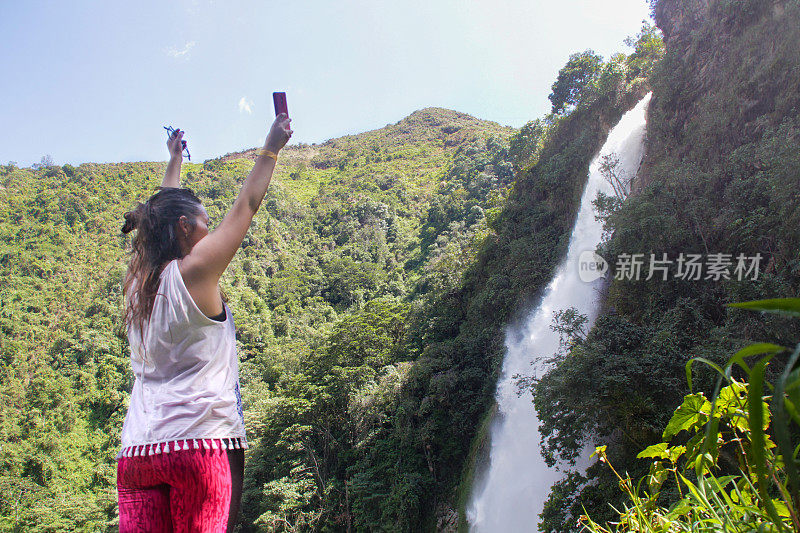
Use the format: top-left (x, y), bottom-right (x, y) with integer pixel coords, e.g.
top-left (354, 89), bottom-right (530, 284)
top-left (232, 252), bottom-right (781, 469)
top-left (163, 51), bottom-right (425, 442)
top-left (117, 440), bottom-right (244, 533)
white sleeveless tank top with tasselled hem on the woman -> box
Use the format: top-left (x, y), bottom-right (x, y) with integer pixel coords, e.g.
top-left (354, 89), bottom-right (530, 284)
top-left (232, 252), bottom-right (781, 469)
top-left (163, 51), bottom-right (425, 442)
top-left (117, 259), bottom-right (247, 457)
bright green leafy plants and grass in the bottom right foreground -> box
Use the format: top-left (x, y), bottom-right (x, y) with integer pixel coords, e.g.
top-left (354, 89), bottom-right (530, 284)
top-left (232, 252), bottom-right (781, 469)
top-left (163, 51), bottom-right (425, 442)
top-left (579, 298), bottom-right (800, 533)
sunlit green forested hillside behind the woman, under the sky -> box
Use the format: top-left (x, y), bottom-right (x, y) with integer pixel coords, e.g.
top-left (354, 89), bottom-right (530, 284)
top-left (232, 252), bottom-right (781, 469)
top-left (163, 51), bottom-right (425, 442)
top-left (0, 108), bottom-right (513, 531)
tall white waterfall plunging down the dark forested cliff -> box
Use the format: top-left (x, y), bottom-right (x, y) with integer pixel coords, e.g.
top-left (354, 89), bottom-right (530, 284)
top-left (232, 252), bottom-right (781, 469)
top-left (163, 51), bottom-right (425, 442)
top-left (467, 94), bottom-right (650, 533)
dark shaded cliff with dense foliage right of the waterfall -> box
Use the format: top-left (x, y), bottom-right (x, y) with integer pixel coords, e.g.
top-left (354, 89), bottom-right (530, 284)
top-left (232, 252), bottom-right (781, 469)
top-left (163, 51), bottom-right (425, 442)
top-left (535, 0), bottom-right (800, 531)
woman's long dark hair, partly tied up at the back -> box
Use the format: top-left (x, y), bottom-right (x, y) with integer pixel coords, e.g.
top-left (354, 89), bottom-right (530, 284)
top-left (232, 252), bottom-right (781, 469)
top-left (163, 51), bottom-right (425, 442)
top-left (122, 187), bottom-right (202, 332)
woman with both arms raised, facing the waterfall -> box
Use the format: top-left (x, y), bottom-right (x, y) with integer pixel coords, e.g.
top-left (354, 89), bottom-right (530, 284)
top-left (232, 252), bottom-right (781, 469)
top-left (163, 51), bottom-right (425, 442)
top-left (117, 114), bottom-right (292, 533)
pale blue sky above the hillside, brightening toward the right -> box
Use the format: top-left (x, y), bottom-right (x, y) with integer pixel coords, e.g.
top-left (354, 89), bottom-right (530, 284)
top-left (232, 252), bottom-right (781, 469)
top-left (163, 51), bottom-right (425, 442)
top-left (0, 0), bottom-right (649, 166)
